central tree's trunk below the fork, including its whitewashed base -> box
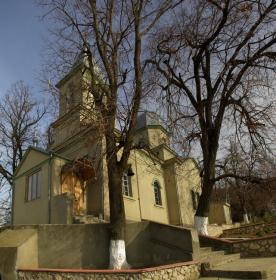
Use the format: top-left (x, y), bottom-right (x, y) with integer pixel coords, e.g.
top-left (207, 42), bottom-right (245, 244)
top-left (108, 160), bottom-right (129, 269)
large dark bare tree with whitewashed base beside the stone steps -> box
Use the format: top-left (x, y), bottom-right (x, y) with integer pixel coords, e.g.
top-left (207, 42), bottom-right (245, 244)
top-left (148, 0), bottom-right (276, 235)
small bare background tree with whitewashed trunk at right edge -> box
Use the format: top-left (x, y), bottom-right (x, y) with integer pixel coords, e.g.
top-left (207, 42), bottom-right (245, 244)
top-left (224, 141), bottom-right (276, 224)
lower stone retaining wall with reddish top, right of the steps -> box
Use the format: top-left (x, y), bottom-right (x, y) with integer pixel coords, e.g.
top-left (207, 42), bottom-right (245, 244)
top-left (232, 235), bottom-right (276, 257)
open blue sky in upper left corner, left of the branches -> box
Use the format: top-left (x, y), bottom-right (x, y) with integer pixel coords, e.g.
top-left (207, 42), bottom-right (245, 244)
top-left (0, 0), bottom-right (47, 96)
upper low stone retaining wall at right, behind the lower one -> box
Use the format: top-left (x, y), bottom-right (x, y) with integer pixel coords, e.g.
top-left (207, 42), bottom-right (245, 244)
top-left (221, 223), bottom-right (276, 237)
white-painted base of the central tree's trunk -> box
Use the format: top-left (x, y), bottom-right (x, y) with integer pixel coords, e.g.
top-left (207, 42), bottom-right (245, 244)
top-left (109, 240), bottom-right (130, 269)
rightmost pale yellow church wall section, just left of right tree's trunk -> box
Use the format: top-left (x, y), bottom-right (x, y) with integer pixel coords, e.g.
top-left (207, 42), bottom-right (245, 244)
top-left (176, 159), bottom-right (201, 225)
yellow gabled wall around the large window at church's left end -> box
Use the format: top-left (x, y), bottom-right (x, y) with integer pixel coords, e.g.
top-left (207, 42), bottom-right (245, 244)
top-left (13, 160), bottom-right (49, 225)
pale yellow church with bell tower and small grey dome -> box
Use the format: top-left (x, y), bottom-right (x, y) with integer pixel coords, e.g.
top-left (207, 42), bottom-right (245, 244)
top-left (12, 52), bottom-right (200, 228)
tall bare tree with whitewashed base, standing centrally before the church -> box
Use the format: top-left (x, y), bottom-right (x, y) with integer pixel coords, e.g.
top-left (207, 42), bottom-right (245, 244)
top-left (39, 0), bottom-right (181, 269)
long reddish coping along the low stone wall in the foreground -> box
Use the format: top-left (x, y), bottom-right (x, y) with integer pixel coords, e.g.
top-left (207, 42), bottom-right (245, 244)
top-left (17, 261), bottom-right (199, 274)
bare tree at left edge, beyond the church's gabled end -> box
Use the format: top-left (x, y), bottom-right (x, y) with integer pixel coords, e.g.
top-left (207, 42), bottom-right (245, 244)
top-left (0, 81), bottom-right (46, 223)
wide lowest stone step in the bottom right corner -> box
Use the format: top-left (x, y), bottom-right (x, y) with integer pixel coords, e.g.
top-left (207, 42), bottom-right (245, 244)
top-left (202, 257), bottom-right (276, 279)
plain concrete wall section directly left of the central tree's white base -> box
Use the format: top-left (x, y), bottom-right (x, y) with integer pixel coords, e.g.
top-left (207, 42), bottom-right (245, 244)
top-left (38, 224), bottom-right (109, 268)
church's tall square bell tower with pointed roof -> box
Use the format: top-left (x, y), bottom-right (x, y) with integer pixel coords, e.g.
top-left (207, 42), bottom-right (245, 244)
top-left (49, 51), bottom-right (93, 151)
